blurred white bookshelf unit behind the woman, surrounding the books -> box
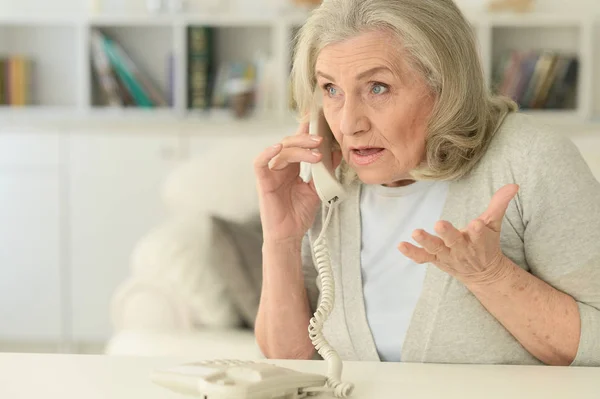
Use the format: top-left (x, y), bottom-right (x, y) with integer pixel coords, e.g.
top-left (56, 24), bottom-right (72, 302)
top-left (0, 12), bottom-right (600, 123)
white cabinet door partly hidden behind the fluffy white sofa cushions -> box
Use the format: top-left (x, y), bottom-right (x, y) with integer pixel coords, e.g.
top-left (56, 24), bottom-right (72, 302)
top-left (68, 130), bottom-right (181, 342)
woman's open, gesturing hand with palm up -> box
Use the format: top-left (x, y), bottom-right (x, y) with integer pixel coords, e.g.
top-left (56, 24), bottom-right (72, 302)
top-left (398, 184), bottom-right (519, 286)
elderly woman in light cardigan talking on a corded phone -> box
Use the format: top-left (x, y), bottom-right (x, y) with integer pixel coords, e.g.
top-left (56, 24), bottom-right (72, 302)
top-left (255, 0), bottom-right (600, 366)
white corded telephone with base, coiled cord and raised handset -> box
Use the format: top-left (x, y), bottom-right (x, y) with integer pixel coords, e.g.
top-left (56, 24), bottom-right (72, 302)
top-left (153, 108), bottom-right (354, 399)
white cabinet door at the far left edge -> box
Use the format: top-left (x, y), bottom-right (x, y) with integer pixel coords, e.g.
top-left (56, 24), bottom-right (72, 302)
top-left (0, 132), bottom-right (64, 343)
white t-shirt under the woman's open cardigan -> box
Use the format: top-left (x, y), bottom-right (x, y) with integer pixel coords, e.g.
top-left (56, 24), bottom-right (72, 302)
top-left (360, 181), bottom-right (449, 362)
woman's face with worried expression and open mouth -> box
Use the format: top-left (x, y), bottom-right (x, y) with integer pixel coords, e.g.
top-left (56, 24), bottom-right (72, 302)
top-left (316, 32), bottom-right (434, 186)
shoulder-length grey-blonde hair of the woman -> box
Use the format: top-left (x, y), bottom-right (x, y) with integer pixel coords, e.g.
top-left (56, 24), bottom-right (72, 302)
top-left (292, 0), bottom-right (517, 180)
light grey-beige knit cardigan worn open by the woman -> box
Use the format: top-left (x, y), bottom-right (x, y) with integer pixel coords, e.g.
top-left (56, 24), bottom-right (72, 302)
top-left (303, 113), bottom-right (600, 366)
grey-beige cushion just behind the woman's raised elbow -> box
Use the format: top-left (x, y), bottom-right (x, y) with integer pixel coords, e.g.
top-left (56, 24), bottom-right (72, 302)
top-left (210, 215), bottom-right (262, 328)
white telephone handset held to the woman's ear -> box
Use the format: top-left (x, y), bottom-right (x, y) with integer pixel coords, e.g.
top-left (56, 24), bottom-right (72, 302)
top-left (309, 108), bottom-right (344, 203)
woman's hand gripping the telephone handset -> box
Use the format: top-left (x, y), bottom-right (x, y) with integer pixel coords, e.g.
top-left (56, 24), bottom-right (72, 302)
top-left (254, 123), bottom-right (341, 244)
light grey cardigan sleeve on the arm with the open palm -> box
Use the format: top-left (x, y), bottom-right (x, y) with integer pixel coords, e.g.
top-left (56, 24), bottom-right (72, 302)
top-left (518, 132), bottom-right (600, 366)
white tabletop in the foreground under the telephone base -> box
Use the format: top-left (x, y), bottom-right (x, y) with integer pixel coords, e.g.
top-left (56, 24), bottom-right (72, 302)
top-left (0, 354), bottom-right (600, 399)
